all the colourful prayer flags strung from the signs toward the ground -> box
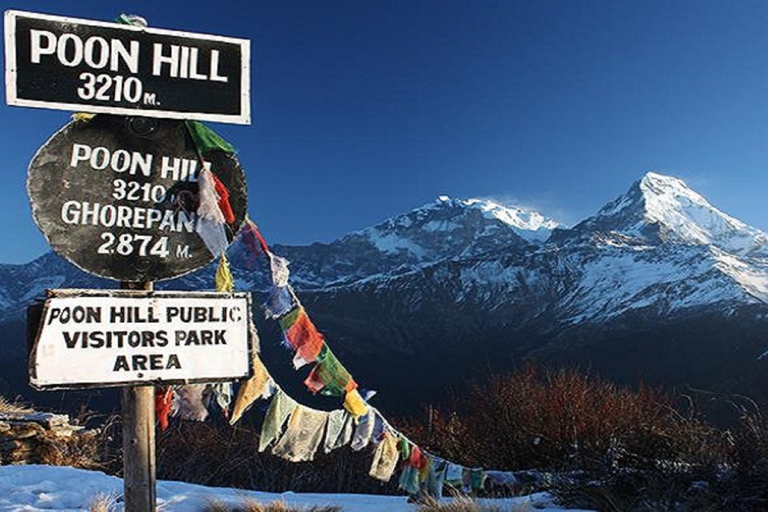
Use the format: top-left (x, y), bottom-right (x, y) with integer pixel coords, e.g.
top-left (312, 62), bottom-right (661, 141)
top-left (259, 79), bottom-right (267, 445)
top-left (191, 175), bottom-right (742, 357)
top-left (175, 121), bottom-right (510, 498)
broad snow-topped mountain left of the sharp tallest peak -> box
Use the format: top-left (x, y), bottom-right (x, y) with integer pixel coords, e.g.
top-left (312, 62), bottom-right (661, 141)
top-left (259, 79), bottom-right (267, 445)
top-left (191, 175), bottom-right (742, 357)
top-left (235, 196), bottom-right (559, 290)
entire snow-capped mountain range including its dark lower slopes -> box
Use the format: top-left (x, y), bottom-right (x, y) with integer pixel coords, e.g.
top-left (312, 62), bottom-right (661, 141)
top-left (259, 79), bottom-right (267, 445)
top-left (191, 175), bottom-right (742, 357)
top-left (0, 173), bottom-right (768, 412)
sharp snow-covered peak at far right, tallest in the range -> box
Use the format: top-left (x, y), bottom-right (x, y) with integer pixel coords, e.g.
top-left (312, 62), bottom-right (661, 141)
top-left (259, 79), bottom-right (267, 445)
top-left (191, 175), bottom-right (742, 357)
top-left (557, 172), bottom-right (768, 322)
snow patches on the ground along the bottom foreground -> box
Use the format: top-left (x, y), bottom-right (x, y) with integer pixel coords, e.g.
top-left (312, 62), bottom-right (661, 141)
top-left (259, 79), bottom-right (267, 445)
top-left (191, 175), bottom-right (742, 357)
top-left (0, 465), bottom-right (592, 512)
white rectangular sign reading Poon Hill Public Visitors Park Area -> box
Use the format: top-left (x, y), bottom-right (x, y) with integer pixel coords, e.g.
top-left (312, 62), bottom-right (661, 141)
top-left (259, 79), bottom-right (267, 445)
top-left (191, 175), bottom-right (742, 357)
top-left (29, 290), bottom-right (253, 389)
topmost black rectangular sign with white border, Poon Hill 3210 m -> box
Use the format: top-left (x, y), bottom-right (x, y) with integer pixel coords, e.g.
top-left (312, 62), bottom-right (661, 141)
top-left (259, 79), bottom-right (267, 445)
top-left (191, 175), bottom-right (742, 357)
top-left (5, 11), bottom-right (251, 124)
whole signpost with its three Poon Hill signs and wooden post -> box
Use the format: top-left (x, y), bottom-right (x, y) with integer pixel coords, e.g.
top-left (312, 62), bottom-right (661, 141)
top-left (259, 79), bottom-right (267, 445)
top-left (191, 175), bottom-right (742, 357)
top-left (4, 11), bottom-right (252, 512)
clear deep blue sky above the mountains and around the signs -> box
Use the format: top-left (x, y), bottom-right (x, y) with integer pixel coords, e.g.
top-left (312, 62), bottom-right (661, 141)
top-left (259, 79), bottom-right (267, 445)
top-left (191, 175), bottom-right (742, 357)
top-left (0, 0), bottom-right (768, 263)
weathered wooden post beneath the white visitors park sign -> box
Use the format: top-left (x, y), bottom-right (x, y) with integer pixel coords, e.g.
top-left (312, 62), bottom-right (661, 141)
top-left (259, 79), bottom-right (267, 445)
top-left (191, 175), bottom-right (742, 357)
top-left (120, 282), bottom-right (156, 512)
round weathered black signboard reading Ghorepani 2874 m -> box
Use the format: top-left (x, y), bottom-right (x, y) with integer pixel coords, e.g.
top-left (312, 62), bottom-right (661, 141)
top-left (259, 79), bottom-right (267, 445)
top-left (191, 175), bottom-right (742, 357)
top-left (27, 115), bottom-right (246, 282)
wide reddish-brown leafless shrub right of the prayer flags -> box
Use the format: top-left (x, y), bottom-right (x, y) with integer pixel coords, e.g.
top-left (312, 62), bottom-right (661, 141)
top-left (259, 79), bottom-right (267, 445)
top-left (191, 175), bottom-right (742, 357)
top-left (409, 365), bottom-right (727, 471)
